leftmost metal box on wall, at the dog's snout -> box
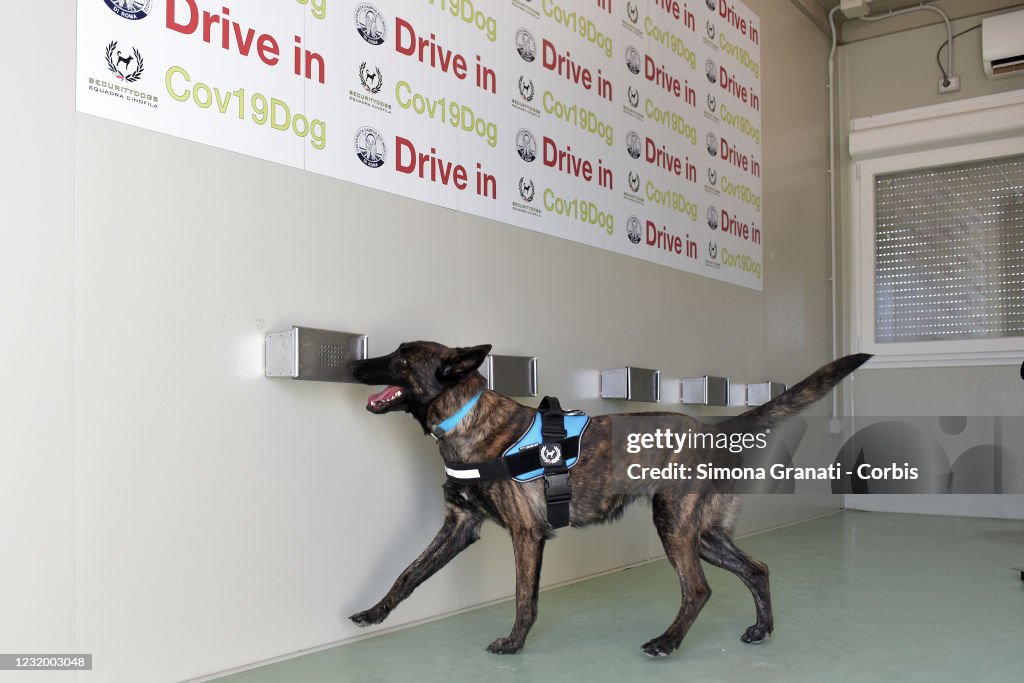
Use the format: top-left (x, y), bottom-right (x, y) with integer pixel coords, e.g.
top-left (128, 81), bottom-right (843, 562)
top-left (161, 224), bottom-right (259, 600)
top-left (263, 327), bottom-right (367, 382)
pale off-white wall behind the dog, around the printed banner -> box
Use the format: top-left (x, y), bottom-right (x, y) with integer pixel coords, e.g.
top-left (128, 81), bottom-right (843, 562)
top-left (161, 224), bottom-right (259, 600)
top-left (0, 1), bottom-right (839, 683)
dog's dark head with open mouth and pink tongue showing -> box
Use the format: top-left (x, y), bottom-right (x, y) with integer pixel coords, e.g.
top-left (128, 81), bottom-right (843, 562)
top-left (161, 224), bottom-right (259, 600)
top-left (352, 342), bottom-right (490, 422)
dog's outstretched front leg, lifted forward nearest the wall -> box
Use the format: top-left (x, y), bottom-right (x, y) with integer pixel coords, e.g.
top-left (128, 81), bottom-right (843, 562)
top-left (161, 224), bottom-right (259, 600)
top-left (348, 506), bottom-right (481, 626)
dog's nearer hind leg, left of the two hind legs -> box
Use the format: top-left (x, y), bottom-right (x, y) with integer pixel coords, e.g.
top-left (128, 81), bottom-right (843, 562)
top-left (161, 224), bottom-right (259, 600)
top-left (643, 494), bottom-right (711, 657)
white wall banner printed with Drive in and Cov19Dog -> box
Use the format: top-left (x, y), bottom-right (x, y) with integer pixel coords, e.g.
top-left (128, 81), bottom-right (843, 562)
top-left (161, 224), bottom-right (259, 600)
top-left (77, 0), bottom-right (764, 290)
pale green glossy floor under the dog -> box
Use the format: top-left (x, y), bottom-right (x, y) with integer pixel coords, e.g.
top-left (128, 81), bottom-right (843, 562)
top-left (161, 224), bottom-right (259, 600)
top-left (219, 512), bottom-right (1024, 683)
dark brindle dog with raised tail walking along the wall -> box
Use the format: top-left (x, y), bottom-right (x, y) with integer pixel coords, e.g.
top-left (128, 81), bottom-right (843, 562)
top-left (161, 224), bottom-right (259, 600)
top-left (349, 342), bottom-right (870, 656)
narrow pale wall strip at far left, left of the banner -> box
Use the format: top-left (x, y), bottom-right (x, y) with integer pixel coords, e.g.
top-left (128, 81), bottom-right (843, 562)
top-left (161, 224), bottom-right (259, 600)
top-left (0, 3), bottom-right (75, 683)
